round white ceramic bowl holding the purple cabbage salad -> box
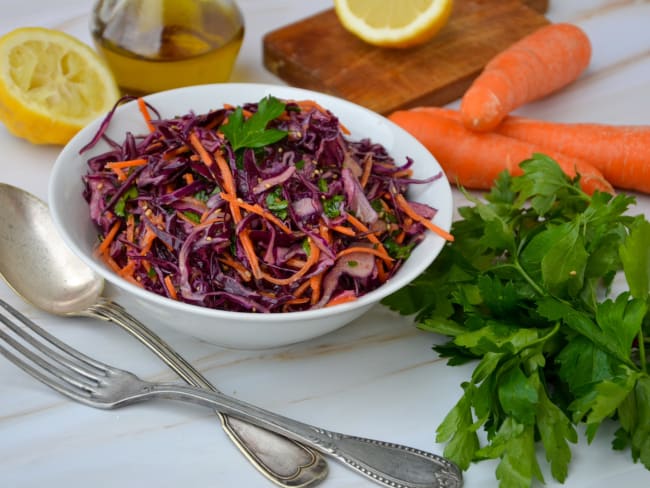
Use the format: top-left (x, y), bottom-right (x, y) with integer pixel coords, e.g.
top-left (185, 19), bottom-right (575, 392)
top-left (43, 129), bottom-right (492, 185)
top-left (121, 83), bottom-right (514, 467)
top-left (49, 83), bottom-right (452, 349)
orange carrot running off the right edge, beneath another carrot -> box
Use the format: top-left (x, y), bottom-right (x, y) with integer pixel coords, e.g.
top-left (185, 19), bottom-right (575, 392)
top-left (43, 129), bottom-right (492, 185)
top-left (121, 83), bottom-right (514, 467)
top-left (412, 107), bottom-right (650, 193)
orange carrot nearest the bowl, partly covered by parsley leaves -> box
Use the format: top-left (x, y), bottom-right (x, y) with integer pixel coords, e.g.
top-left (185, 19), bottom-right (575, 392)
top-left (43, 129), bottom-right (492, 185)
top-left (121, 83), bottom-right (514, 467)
top-left (389, 110), bottom-right (614, 193)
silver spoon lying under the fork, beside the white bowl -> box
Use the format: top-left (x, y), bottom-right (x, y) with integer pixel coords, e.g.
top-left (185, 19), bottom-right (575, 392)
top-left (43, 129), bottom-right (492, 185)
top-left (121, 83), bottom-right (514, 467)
top-left (0, 183), bottom-right (328, 487)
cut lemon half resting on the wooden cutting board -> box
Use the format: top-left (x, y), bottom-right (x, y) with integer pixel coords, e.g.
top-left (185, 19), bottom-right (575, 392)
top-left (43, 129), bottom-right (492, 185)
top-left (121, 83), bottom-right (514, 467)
top-left (334, 0), bottom-right (453, 47)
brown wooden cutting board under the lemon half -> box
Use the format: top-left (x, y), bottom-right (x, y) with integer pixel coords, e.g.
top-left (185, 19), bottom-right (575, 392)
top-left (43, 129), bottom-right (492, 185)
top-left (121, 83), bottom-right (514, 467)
top-left (263, 0), bottom-right (549, 114)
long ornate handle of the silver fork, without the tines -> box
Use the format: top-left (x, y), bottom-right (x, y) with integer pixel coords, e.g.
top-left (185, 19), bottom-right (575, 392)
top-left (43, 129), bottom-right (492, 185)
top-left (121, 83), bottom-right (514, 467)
top-left (146, 383), bottom-right (463, 488)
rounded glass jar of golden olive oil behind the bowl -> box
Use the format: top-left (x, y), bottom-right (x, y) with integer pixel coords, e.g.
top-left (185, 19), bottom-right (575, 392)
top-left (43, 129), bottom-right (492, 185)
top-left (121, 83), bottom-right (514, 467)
top-left (91, 0), bottom-right (244, 96)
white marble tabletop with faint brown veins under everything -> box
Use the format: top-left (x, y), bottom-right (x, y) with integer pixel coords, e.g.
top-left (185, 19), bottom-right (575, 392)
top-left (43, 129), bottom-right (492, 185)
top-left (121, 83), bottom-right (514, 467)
top-left (0, 0), bottom-right (650, 488)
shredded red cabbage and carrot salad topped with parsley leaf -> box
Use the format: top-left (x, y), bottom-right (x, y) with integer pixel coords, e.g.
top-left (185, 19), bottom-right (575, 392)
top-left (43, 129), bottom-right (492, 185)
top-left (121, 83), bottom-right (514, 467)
top-left (81, 96), bottom-right (452, 313)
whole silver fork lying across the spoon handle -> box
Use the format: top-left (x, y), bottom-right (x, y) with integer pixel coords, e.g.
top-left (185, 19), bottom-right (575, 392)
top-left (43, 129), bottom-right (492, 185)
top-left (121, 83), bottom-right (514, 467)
top-left (0, 300), bottom-right (462, 488)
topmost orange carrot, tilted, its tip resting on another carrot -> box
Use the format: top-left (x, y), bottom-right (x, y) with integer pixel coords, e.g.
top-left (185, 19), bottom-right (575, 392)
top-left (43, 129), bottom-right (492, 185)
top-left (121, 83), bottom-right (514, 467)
top-left (460, 23), bottom-right (591, 131)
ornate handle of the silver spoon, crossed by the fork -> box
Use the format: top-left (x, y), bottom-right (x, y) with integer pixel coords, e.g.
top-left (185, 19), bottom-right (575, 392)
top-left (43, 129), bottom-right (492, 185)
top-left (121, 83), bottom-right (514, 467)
top-left (87, 300), bottom-right (328, 487)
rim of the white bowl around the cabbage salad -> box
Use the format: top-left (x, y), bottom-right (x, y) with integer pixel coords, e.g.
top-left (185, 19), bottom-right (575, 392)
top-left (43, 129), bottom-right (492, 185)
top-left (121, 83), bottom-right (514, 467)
top-left (48, 82), bottom-right (453, 322)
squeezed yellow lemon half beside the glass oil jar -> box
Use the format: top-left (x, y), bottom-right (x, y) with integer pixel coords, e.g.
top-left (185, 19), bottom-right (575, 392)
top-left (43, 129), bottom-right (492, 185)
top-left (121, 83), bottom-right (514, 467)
top-left (0, 27), bottom-right (120, 145)
